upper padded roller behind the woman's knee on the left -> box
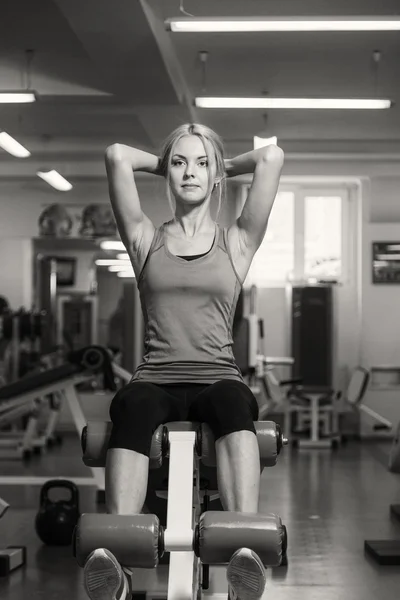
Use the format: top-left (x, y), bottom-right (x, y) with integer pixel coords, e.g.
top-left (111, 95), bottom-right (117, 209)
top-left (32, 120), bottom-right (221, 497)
top-left (81, 421), bottom-right (168, 469)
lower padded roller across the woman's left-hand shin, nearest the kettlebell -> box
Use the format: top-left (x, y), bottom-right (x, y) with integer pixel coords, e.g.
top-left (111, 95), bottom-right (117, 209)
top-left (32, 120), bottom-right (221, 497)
top-left (73, 513), bottom-right (164, 569)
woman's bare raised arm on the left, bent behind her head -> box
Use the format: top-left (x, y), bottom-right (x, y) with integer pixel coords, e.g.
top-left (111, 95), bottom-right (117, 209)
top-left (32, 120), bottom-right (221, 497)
top-left (105, 144), bottom-right (159, 248)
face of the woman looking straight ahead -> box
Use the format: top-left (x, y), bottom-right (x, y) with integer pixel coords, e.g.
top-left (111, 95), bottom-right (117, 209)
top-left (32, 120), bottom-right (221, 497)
top-left (170, 135), bottom-right (216, 204)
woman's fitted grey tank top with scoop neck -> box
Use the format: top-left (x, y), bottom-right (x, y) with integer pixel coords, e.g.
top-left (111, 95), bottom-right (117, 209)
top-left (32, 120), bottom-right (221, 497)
top-left (131, 224), bottom-right (243, 384)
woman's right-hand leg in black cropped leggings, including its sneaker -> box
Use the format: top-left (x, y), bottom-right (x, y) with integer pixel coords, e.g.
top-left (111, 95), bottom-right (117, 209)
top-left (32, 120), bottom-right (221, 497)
top-left (189, 379), bottom-right (266, 600)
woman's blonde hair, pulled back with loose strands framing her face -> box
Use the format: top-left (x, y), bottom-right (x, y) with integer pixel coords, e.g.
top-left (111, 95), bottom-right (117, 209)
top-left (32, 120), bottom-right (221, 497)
top-left (159, 123), bottom-right (226, 221)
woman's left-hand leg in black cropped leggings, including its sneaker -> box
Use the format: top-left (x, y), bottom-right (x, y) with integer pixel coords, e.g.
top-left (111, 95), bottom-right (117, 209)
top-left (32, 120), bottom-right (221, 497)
top-left (84, 382), bottom-right (179, 600)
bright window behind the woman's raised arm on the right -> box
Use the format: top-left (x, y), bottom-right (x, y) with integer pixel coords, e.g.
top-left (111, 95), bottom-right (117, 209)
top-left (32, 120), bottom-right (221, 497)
top-left (241, 185), bottom-right (349, 287)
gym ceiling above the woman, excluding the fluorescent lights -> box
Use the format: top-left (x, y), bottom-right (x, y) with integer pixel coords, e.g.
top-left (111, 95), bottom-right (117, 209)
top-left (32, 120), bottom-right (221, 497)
top-left (0, 0), bottom-right (400, 177)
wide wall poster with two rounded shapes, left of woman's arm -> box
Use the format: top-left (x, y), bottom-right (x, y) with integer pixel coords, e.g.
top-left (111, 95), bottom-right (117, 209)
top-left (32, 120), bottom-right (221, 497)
top-left (38, 203), bottom-right (119, 239)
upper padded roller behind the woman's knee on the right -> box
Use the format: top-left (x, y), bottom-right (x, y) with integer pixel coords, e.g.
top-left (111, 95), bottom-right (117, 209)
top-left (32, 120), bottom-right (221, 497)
top-left (200, 421), bottom-right (283, 467)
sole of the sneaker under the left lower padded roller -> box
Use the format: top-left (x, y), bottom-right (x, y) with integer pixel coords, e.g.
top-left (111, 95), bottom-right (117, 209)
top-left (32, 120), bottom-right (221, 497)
top-left (83, 548), bottom-right (128, 600)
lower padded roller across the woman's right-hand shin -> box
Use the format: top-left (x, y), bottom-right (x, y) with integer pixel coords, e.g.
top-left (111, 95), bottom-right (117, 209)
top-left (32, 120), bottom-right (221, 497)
top-left (195, 511), bottom-right (285, 567)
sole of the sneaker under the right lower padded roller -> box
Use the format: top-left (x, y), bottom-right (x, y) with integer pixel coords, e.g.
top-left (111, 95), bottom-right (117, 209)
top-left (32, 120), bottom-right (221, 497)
top-left (226, 548), bottom-right (267, 600)
